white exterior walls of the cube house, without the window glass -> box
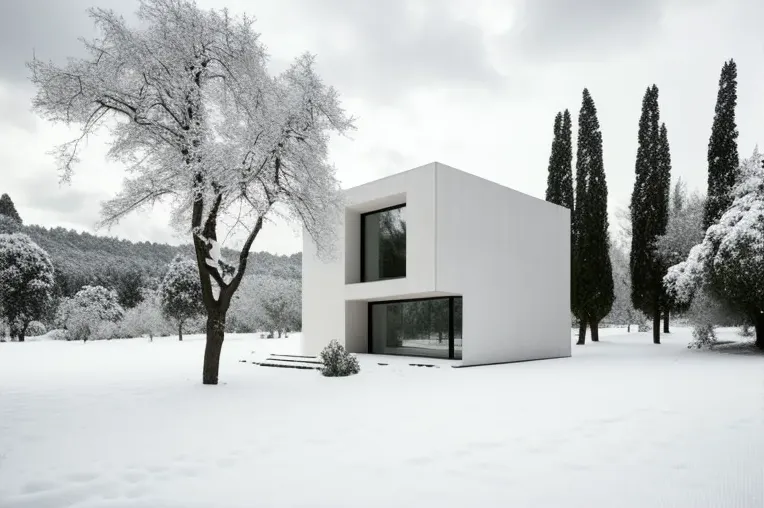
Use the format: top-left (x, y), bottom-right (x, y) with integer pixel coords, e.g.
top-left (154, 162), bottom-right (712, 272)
top-left (302, 163), bottom-right (570, 365)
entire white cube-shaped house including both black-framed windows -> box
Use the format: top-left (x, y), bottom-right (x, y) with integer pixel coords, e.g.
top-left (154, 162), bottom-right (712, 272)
top-left (302, 162), bottom-right (571, 366)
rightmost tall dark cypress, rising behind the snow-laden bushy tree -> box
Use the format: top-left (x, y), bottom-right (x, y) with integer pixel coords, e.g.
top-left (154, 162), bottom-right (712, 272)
top-left (703, 60), bottom-right (739, 229)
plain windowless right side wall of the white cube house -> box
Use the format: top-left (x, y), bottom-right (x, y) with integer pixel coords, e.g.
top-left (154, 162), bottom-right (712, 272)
top-left (436, 164), bottom-right (571, 365)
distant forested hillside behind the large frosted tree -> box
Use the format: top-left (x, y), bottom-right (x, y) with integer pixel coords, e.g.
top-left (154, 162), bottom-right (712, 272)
top-left (19, 225), bottom-right (302, 307)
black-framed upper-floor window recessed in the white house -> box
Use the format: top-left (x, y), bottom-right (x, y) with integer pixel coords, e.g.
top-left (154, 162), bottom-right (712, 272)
top-left (361, 204), bottom-right (406, 282)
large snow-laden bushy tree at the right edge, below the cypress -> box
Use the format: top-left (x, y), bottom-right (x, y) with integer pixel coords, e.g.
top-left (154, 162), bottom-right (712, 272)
top-left (664, 150), bottom-right (764, 349)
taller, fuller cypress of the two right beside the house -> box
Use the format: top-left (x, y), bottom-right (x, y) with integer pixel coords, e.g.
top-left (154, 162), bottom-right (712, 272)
top-left (571, 89), bottom-right (615, 344)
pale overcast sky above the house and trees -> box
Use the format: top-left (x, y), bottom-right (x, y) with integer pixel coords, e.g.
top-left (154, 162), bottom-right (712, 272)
top-left (0, 0), bottom-right (764, 254)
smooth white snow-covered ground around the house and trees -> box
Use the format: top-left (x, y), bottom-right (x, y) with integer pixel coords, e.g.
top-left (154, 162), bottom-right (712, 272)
top-left (0, 329), bottom-right (764, 508)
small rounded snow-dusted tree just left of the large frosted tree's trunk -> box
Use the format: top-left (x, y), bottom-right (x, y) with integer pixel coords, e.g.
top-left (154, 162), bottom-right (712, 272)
top-left (159, 256), bottom-right (204, 340)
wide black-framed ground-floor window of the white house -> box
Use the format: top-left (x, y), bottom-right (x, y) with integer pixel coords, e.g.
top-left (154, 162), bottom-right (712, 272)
top-left (369, 296), bottom-right (462, 360)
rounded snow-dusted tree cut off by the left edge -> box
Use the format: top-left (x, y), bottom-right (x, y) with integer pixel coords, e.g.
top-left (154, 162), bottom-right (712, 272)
top-left (0, 233), bottom-right (54, 341)
